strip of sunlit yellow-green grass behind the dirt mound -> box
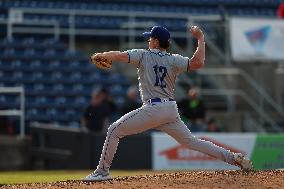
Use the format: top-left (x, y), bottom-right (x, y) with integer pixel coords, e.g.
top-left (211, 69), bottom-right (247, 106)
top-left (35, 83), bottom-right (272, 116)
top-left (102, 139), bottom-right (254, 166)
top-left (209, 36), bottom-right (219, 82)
top-left (0, 170), bottom-right (156, 184)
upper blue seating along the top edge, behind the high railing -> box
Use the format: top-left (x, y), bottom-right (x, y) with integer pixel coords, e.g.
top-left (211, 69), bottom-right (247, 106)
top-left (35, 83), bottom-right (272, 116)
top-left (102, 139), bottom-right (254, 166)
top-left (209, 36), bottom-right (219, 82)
top-left (0, 0), bottom-right (282, 31)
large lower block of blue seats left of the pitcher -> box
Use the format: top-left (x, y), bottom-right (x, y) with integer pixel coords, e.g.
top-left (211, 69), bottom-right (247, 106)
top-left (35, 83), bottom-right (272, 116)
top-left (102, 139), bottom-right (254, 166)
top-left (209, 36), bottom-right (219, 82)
top-left (0, 38), bottom-right (129, 126)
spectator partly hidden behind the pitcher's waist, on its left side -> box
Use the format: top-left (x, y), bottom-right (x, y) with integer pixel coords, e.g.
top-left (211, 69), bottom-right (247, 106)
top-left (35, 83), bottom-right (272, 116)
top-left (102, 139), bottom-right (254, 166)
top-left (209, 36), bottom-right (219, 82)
top-left (121, 85), bottom-right (141, 115)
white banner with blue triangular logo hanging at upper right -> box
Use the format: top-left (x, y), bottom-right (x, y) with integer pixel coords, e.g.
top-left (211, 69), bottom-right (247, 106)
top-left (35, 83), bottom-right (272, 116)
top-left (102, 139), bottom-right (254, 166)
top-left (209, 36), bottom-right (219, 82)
top-left (230, 18), bottom-right (284, 61)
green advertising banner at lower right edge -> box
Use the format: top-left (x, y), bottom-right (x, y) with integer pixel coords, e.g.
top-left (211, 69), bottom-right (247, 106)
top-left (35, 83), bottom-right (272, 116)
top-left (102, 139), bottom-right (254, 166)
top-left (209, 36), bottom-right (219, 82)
top-left (252, 135), bottom-right (284, 170)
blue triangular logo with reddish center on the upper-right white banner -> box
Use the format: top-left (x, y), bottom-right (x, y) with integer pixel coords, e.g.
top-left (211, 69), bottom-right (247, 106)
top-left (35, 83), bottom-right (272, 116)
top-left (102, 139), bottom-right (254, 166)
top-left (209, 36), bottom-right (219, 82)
top-left (245, 26), bottom-right (271, 52)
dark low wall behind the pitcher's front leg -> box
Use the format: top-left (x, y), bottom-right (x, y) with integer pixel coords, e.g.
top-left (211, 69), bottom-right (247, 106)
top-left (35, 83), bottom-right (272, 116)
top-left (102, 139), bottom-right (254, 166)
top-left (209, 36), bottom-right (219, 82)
top-left (31, 126), bottom-right (152, 169)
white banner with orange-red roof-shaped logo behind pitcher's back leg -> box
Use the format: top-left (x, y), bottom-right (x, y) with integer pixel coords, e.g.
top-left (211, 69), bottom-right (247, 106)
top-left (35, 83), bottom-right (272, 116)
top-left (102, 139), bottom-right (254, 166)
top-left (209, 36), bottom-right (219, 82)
top-left (152, 133), bottom-right (256, 170)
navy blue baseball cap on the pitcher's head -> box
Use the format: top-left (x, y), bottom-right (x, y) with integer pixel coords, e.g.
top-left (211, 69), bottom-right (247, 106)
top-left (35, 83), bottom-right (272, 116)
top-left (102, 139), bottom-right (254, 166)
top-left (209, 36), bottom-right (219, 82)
top-left (143, 26), bottom-right (171, 42)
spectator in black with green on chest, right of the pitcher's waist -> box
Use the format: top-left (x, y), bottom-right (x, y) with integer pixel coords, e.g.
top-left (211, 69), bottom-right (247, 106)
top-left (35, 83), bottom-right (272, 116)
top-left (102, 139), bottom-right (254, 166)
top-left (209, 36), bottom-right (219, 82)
top-left (178, 87), bottom-right (207, 132)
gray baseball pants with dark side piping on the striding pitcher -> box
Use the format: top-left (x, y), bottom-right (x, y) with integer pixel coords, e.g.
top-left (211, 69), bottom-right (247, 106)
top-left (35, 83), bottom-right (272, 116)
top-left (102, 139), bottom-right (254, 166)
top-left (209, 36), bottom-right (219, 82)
top-left (97, 101), bottom-right (234, 171)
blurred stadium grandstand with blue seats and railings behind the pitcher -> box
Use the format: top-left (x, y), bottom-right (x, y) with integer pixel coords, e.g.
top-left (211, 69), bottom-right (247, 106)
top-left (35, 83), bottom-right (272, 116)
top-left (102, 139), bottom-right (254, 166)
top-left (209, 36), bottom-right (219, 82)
top-left (0, 0), bottom-right (284, 135)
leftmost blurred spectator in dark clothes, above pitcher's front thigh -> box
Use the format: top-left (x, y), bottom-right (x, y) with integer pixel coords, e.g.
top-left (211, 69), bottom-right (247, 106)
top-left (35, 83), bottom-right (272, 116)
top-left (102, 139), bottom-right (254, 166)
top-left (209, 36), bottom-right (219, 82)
top-left (81, 88), bottom-right (116, 133)
